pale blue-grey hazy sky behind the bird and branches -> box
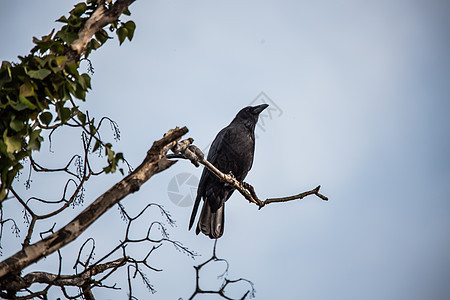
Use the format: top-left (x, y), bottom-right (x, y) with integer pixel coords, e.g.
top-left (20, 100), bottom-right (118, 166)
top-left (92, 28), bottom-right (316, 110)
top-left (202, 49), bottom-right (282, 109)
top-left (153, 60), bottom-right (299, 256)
top-left (0, 0), bottom-right (450, 300)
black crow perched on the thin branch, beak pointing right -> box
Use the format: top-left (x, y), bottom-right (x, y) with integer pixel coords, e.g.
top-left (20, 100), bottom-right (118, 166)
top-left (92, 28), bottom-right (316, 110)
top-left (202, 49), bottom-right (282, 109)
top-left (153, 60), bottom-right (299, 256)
top-left (189, 104), bottom-right (269, 239)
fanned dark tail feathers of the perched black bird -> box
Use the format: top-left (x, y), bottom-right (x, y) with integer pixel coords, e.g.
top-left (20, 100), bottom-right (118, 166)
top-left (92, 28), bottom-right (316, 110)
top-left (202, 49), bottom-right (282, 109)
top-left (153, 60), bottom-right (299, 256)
top-left (195, 201), bottom-right (225, 239)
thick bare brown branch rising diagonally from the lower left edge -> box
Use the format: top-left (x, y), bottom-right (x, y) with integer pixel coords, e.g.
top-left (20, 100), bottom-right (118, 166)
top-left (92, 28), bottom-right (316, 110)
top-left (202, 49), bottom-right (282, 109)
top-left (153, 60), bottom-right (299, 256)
top-left (0, 127), bottom-right (188, 285)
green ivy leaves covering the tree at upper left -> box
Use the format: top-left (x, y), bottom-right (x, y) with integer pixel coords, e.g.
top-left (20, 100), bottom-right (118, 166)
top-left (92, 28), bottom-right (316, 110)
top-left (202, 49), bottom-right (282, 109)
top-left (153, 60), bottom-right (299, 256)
top-left (0, 0), bottom-right (136, 201)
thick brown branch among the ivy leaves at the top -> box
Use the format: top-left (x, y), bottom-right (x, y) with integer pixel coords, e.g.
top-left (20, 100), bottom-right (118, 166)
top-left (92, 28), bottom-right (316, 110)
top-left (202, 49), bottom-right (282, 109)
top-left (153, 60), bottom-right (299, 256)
top-left (71, 0), bottom-right (135, 55)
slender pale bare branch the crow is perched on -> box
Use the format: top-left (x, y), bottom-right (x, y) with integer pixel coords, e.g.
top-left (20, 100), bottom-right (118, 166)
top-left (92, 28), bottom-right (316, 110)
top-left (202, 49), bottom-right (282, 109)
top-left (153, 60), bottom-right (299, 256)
top-left (167, 138), bottom-right (328, 209)
